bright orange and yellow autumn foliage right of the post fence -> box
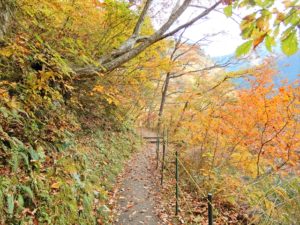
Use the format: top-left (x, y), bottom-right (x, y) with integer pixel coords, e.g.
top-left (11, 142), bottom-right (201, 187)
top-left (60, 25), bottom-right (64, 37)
top-left (150, 59), bottom-right (300, 224)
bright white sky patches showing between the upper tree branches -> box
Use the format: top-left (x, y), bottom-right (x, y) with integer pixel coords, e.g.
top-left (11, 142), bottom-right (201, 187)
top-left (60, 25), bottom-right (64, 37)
top-left (150, 0), bottom-right (290, 57)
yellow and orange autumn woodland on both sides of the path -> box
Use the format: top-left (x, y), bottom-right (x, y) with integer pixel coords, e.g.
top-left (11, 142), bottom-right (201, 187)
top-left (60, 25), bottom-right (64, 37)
top-left (0, 0), bottom-right (300, 224)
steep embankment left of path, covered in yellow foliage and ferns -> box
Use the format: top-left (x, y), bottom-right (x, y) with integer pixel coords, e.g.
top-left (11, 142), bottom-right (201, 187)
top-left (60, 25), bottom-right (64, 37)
top-left (0, 0), bottom-right (149, 225)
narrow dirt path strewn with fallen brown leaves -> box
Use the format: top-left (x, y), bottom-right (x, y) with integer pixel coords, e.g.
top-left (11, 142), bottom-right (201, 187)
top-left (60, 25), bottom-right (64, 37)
top-left (114, 131), bottom-right (162, 225)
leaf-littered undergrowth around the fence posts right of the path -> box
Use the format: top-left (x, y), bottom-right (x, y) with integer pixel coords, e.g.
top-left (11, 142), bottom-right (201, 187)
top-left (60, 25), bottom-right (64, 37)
top-left (158, 145), bottom-right (300, 225)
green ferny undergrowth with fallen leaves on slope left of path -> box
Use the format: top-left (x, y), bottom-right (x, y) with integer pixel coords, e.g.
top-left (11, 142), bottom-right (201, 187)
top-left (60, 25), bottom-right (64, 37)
top-left (0, 126), bottom-right (138, 225)
